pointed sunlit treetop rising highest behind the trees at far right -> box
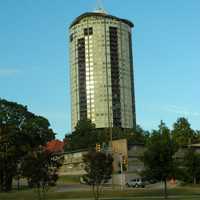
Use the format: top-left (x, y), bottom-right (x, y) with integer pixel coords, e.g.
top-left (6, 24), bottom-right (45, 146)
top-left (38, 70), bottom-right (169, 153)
top-left (172, 117), bottom-right (197, 146)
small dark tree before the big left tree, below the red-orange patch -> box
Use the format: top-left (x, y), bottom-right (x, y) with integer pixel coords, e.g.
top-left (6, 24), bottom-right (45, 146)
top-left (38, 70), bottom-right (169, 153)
top-left (22, 147), bottom-right (63, 200)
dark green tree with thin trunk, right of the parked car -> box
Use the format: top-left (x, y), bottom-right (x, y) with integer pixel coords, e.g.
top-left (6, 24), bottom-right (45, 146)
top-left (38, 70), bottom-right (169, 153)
top-left (143, 122), bottom-right (177, 198)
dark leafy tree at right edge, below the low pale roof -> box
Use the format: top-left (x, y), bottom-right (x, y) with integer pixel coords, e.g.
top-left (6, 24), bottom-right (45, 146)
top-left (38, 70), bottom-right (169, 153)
top-left (183, 148), bottom-right (200, 184)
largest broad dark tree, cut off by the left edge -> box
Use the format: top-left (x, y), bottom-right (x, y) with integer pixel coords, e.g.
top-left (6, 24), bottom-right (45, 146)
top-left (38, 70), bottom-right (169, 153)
top-left (0, 99), bottom-right (54, 191)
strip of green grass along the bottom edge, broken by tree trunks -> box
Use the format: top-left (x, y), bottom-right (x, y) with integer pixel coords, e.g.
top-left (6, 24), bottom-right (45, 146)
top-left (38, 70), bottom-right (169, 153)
top-left (0, 187), bottom-right (200, 200)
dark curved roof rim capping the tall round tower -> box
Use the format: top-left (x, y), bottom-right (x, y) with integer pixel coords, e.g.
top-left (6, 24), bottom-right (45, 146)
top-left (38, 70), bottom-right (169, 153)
top-left (70, 11), bottom-right (134, 28)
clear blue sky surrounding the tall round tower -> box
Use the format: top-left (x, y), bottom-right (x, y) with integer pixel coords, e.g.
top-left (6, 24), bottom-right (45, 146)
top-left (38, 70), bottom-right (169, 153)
top-left (0, 0), bottom-right (200, 139)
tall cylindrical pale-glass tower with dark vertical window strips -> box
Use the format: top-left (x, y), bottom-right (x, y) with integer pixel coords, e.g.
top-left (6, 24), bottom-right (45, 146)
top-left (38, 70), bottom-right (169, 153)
top-left (70, 12), bottom-right (136, 130)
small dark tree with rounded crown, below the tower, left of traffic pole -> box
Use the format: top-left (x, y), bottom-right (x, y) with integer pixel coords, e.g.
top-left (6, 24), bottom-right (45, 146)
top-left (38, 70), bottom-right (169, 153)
top-left (83, 152), bottom-right (113, 200)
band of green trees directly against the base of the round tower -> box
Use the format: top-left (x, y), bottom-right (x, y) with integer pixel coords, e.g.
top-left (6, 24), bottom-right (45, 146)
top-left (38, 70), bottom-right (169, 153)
top-left (64, 119), bottom-right (148, 151)
